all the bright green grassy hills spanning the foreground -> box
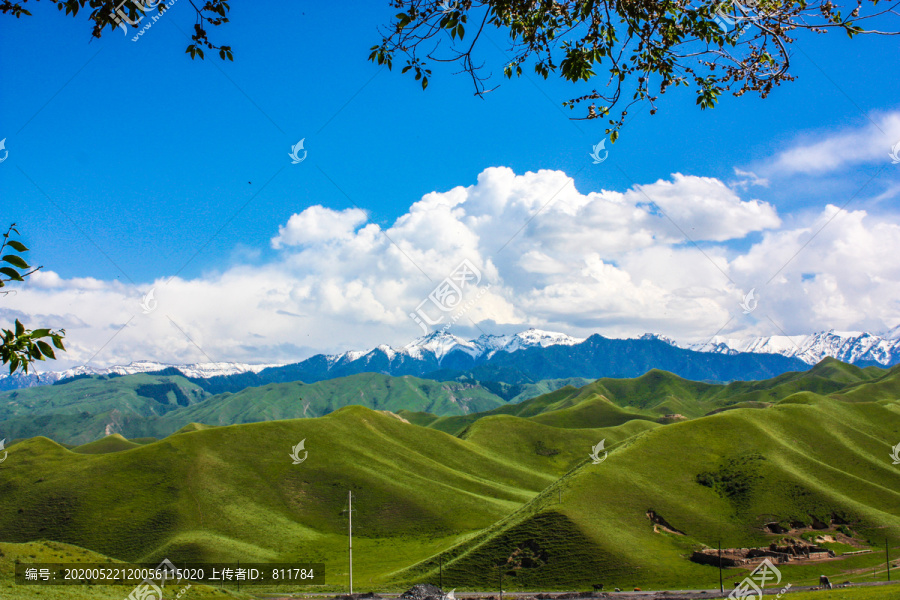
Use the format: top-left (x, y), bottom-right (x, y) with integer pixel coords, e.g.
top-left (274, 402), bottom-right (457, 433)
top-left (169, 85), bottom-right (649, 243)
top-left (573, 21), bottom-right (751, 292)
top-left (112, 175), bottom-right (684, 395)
top-left (0, 364), bottom-right (900, 589)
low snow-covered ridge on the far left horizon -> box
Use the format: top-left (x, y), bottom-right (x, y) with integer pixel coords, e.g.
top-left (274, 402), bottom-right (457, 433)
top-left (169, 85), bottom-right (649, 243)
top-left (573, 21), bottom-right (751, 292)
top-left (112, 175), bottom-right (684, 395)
top-left (0, 360), bottom-right (279, 390)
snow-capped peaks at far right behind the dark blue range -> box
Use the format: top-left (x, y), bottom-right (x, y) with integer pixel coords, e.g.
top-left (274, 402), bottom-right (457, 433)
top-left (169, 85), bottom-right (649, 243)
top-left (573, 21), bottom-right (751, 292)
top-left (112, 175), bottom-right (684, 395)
top-left (680, 327), bottom-right (900, 366)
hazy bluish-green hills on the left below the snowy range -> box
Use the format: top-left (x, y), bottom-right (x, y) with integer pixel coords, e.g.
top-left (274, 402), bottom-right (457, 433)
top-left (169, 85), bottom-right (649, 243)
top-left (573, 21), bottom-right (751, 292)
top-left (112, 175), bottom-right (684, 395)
top-left (0, 369), bottom-right (586, 445)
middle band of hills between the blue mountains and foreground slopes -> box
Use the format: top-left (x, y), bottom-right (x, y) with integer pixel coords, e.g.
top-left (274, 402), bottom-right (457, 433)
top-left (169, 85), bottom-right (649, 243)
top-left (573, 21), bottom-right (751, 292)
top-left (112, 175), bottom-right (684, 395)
top-left (0, 359), bottom-right (895, 445)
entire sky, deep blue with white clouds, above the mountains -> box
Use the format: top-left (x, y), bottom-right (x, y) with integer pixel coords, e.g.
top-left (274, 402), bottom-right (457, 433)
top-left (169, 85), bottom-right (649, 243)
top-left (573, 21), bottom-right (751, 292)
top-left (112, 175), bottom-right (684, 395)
top-left (0, 0), bottom-right (900, 364)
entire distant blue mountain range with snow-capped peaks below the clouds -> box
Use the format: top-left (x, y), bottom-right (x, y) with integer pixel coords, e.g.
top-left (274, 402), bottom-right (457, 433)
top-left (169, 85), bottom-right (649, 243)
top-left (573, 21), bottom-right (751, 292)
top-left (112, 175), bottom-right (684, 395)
top-left (0, 327), bottom-right (900, 393)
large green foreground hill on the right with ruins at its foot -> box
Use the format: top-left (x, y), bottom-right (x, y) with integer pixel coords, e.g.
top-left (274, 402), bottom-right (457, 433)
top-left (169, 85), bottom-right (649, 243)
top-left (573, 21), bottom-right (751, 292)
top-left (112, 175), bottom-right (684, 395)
top-left (394, 392), bottom-right (900, 589)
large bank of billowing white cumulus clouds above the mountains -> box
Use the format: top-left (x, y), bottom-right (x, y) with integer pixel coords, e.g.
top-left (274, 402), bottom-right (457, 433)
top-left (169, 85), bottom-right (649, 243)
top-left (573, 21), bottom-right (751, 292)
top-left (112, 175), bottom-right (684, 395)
top-left (7, 167), bottom-right (900, 370)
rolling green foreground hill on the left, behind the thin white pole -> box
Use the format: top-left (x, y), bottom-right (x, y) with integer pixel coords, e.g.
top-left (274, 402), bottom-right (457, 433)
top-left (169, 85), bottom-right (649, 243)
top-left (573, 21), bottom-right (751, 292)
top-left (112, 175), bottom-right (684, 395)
top-left (0, 407), bottom-right (640, 582)
